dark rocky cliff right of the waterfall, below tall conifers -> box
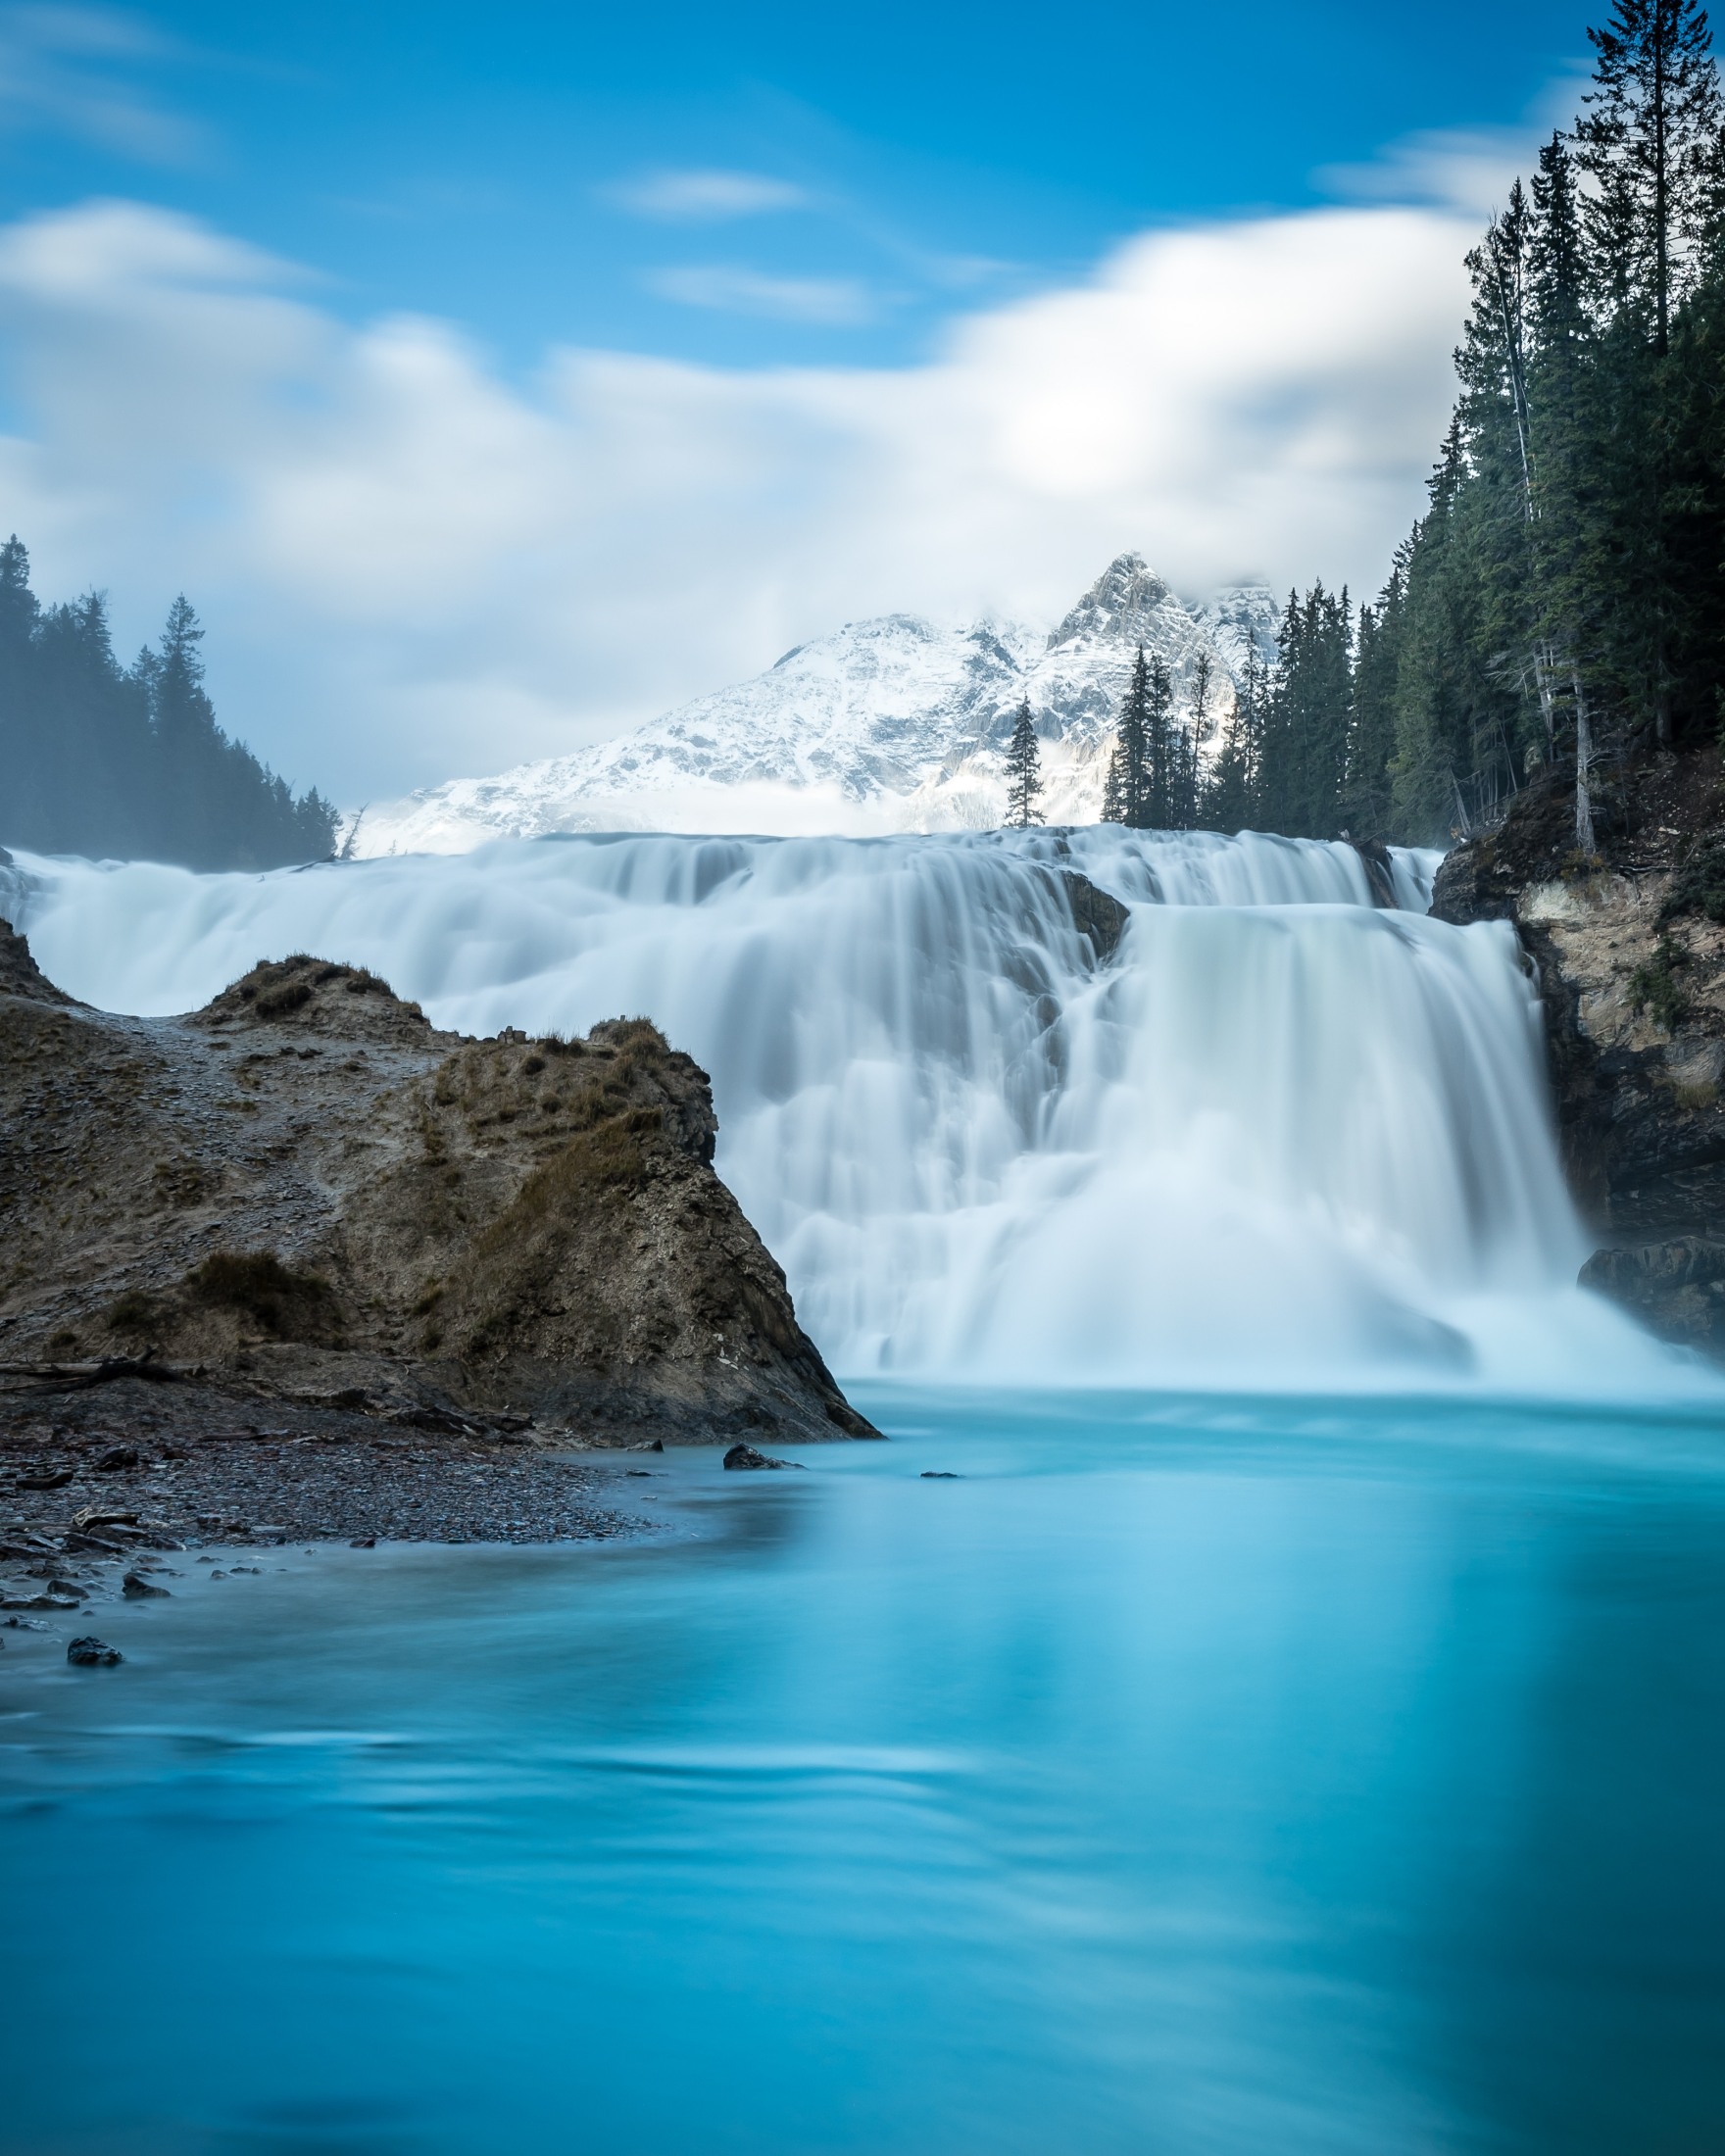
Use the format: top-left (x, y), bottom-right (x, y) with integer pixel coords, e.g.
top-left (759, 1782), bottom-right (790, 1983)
top-left (1432, 751), bottom-right (1725, 1351)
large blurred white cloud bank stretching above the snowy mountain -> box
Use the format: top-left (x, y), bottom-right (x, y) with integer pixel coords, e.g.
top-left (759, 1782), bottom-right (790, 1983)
top-left (0, 203), bottom-right (1475, 802)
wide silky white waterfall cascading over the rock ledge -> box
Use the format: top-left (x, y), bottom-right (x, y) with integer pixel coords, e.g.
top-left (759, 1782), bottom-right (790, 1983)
top-left (13, 828), bottom-right (1675, 1391)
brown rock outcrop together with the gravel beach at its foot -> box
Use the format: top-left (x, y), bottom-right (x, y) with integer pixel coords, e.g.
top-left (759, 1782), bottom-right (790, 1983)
top-left (0, 923), bottom-right (880, 1628)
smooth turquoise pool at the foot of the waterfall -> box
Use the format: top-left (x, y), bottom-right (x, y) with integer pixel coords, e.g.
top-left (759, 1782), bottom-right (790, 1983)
top-left (0, 1395), bottom-right (1725, 2156)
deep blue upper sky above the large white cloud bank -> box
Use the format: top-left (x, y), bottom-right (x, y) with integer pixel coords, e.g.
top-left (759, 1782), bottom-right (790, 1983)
top-left (2, 0), bottom-right (1585, 365)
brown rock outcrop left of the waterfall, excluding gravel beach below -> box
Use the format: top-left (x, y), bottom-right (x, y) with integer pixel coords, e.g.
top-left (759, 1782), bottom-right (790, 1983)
top-left (0, 934), bottom-right (873, 1443)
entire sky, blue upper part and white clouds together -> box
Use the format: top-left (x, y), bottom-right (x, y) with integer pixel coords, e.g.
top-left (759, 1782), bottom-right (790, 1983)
top-left (0, 0), bottom-right (1585, 798)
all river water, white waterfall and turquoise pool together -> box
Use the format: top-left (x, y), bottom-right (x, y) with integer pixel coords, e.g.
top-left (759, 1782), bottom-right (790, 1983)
top-left (0, 830), bottom-right (1725, 2156)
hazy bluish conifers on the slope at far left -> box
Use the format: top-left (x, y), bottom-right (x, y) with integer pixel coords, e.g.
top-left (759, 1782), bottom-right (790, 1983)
top-left (0, 537), bottom-right (336, 869)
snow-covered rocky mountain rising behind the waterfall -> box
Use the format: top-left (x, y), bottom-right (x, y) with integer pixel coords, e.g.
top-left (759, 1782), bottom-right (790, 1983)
top-left (349, 554), bottom-right (1276, 856)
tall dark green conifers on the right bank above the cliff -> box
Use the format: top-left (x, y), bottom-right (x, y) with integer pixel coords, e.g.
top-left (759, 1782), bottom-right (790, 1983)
top-left (1086, 0), bottom-right (1725, 854)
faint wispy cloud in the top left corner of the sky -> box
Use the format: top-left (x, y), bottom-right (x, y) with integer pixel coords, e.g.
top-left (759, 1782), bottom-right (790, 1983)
top-left (0, 7), bottom-right (205, 164)
